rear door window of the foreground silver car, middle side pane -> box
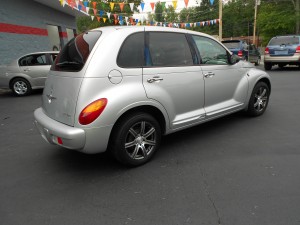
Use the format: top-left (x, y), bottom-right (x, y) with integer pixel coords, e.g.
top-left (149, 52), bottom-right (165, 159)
top-left (145, 32), bottom-right (194, 67)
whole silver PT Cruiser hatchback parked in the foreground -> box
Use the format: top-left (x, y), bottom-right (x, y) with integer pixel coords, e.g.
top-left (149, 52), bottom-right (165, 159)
top-left (34, 26), bottom-right (271, 166)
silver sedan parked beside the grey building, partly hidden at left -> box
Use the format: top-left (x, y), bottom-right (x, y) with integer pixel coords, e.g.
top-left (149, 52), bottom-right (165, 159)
top-left (0, 51), bottom-right (58, 96)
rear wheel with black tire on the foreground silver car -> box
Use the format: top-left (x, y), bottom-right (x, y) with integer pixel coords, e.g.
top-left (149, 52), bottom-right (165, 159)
top-left (110, 112), bottom-right (161, 166)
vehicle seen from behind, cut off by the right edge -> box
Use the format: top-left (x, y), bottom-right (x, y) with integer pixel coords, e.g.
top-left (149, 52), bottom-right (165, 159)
top-left (264, 35), bottom-right (300, 70)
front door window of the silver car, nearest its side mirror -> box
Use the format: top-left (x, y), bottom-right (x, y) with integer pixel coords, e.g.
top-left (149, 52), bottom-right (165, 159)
top-left (193, 35), bottom-right (229, 65)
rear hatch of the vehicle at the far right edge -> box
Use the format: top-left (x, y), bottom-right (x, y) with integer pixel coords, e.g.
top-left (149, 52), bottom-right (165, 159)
top-left (267, 36), bottom-right (300, 57)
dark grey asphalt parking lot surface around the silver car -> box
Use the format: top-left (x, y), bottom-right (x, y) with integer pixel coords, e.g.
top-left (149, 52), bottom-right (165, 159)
top-left (0, 65), bottom-right (300, 225)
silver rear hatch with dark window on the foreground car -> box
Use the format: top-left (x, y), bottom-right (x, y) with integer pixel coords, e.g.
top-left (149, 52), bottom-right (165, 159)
top-left (42, 31), bottom-right (101, 126)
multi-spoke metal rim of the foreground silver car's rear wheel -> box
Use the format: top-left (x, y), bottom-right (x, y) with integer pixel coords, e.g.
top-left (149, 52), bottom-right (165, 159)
top-left (125, 121), bottom-right (157, 160)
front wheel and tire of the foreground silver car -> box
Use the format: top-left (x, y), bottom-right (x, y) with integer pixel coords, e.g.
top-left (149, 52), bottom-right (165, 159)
top-left (247, 82), bottom-right (270, 116)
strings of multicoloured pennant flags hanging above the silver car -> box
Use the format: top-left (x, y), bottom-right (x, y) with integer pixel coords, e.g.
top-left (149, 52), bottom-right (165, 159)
top-left (59, 0), bottom-right (220, 28)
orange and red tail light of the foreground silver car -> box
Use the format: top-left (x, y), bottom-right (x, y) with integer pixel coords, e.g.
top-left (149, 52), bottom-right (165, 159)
top-left (78, 98), bottom-right (107, 125)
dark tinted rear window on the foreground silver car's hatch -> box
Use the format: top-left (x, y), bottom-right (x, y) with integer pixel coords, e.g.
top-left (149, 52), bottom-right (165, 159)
top-left (51, 31), bottom-right (101, 72)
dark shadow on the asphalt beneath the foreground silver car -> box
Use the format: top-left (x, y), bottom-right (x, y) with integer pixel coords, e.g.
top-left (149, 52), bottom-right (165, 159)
top-left (49, 112), bottom-right (249, 173)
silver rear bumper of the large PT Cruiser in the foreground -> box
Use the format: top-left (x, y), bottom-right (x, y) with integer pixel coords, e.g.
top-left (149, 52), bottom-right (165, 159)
top-left (34, 108), bottom-right (112, 154)
